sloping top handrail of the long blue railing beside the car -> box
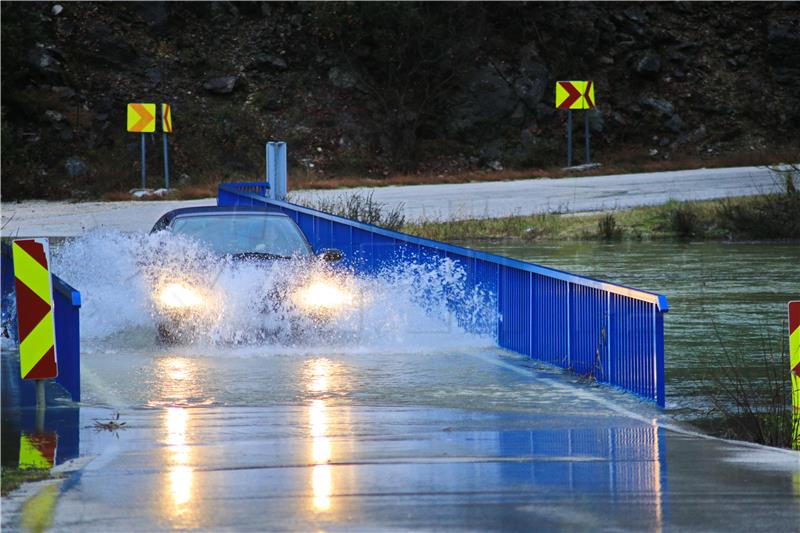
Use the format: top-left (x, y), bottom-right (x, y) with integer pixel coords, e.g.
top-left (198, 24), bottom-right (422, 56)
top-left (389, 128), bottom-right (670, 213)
top-left (219, 183), bottom-right (669, 313)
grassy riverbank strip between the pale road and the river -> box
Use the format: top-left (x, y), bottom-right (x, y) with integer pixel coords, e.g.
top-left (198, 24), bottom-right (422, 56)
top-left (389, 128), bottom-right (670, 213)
top-left (403, 191), bottom-right (800, 241)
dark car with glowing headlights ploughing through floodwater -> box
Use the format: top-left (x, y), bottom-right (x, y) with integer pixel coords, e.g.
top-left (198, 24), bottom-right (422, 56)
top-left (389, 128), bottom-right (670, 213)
top-left (145, 206), bottom-right (355, 343)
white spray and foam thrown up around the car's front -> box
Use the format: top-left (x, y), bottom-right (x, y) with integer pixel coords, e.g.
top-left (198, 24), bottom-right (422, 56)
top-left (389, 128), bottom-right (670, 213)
top-left (53, 231), bottom-right (496, 355)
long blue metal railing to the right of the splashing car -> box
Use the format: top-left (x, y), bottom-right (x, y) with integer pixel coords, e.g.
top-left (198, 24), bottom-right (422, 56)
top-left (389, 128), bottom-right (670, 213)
top-left (217, 183), bottom-right (668, 407)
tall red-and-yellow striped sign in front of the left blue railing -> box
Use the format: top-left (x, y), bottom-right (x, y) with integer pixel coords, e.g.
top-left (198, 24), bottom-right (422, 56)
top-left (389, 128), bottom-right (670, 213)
top-left (12, 239), bottom-right (58, 379)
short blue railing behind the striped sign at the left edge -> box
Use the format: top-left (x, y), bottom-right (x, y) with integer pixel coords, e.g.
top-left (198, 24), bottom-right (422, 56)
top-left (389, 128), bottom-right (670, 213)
top-left (2, 243), bottom-right (81, 406)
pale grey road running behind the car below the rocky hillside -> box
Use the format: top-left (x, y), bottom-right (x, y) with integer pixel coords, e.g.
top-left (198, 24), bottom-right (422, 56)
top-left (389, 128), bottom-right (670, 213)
top-left (2, 167), bottom-right (780, 237)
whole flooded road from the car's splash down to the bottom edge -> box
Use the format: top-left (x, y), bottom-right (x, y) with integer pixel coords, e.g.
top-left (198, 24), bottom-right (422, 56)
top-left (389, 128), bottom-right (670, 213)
top-left (3, 342), bottom-right (800, 532)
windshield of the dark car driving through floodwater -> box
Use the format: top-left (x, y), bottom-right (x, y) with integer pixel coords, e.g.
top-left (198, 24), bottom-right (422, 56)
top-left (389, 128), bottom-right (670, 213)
top-left (172, 214), bottom-right (311, 257)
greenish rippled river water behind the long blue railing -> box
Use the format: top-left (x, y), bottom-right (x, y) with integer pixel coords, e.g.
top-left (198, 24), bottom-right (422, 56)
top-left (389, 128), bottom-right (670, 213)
top-left (460, 241), bottom-right (800, 417)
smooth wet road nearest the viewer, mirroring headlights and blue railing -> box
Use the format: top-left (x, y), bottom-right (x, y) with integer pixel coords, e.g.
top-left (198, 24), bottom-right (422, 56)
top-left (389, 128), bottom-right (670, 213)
top-left (32, 404), bottom-right (800, 531)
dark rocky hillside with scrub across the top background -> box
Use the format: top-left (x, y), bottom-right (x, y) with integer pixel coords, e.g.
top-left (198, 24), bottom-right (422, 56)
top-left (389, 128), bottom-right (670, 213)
top-left (2, 2), bottom-right (800, 200)
